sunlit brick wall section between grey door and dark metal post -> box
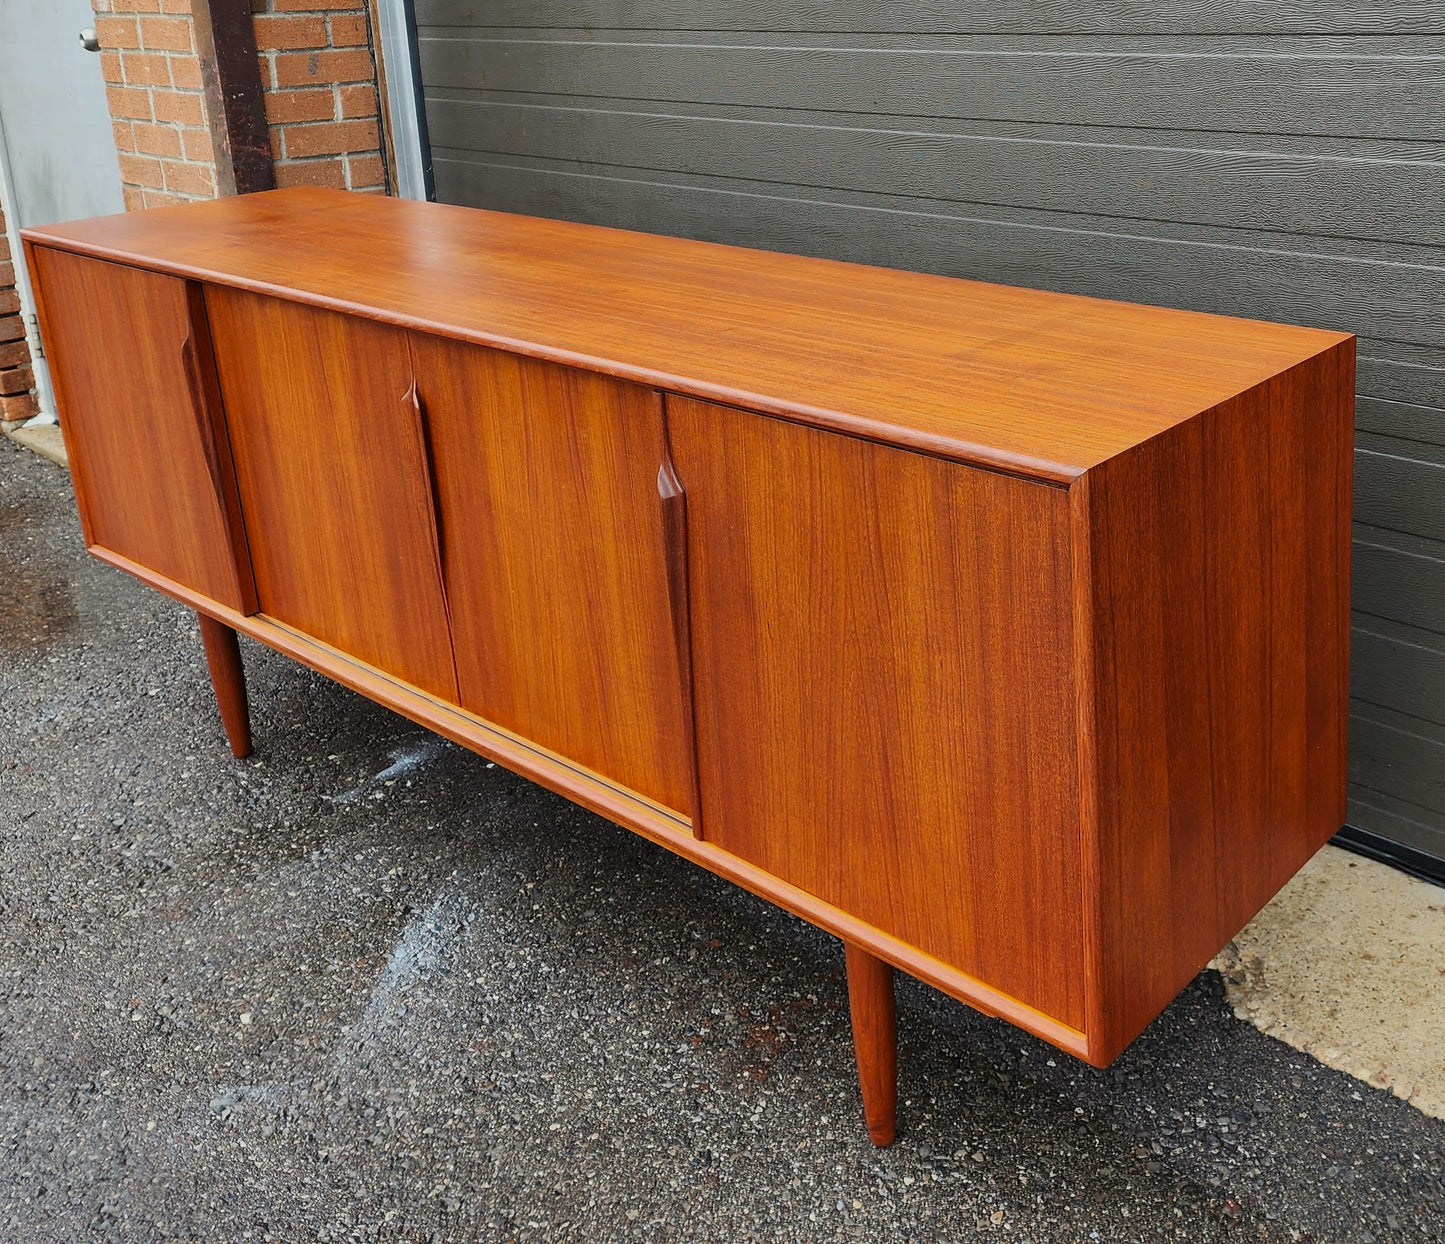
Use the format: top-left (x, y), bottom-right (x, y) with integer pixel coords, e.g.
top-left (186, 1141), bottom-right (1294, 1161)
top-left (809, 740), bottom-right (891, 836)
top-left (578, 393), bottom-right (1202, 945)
top-left (92, 0), bottom-right (218, 211)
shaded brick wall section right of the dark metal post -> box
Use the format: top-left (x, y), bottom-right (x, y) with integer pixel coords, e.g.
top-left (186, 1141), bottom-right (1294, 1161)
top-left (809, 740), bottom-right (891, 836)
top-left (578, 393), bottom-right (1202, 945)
top-left (251, 0), bottom-right (386, 191)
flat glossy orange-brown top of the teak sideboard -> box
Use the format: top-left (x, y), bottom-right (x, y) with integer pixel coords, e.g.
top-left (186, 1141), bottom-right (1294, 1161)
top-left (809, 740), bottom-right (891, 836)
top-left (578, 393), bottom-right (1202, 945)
top-left (25, 186), bottom-right (1350, 483)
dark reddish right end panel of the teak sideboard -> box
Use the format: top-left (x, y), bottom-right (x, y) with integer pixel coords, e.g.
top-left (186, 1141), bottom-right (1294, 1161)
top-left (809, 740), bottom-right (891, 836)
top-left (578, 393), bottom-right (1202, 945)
top-left (1075, 341), bottom-right (1354, 1065)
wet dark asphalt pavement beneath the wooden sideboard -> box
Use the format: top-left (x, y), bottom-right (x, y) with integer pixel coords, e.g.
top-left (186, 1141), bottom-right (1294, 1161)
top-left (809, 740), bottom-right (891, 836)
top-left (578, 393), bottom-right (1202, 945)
top-left (0, 442), bottom-right (1445, 1244)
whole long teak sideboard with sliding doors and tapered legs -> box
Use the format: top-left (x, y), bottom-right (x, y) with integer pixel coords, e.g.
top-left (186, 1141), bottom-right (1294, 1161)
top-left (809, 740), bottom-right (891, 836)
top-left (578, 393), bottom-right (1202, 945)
top-left (25, 189), bottom-right (1354, 1144)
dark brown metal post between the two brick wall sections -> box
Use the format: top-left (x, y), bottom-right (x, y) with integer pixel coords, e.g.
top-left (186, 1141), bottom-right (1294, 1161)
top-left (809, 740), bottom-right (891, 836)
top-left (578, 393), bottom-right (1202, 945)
top-left (191, 0), bottom-right (276, 195)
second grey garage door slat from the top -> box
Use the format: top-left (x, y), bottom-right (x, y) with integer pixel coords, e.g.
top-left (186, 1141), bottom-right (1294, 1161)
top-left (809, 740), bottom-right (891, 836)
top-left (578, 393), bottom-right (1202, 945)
top-left (420, 32), bottom-right (1445, 140)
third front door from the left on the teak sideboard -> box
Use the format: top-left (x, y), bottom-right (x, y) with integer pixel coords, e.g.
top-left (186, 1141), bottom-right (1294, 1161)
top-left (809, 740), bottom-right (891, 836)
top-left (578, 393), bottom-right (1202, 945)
top-left (412, 334), bottom-right (692, 816)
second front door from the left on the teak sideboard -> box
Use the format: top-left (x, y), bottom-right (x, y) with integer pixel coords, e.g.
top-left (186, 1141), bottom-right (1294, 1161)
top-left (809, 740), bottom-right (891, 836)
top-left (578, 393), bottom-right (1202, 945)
top-left (205, 286), bottom-right (457, 702)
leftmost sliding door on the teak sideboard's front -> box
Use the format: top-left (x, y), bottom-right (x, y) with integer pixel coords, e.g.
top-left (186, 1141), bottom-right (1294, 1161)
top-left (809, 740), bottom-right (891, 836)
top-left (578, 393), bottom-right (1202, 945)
top-left (32, 246), bottom-right (256, 613)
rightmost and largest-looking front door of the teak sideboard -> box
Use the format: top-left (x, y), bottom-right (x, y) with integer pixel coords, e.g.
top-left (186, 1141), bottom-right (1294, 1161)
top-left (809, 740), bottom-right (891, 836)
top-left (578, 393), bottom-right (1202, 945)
top-left (668, 396), bottom-right (1084, 1029)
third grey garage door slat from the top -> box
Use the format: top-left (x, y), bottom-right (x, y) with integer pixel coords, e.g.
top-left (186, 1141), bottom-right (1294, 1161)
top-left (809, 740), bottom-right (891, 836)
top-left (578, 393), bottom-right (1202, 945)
top-left (429, 104), bottom-right (1445, 246)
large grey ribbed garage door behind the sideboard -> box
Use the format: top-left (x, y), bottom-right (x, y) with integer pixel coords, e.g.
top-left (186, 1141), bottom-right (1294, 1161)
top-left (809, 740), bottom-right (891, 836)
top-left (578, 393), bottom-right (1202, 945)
top-left (415, 0), bottom-right (1445, 857)
